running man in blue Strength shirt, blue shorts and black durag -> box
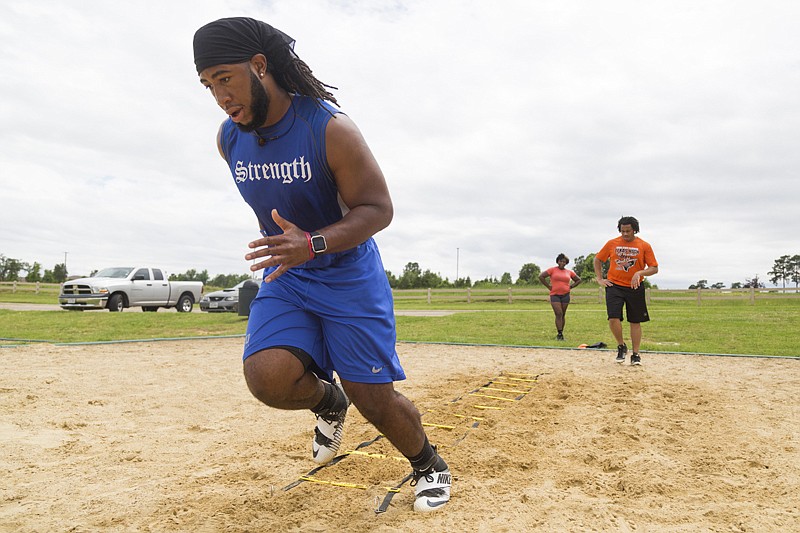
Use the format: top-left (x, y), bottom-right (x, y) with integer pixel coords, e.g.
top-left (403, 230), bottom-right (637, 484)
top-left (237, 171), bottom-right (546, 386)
top-left (194, 17), bottom-right (451, 511)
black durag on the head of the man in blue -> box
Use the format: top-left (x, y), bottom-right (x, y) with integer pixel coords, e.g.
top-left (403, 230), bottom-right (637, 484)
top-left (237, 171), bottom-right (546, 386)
top-left (194, 17), bottom-right (295, 74)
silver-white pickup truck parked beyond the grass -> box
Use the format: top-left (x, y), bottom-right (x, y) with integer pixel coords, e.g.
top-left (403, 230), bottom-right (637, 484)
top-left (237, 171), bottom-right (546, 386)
top-left (58, 267), bottom-right (203, 313)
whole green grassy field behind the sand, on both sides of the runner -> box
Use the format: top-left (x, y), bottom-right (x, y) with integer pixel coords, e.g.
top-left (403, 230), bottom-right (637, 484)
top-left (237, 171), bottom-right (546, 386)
top-left (0, 293), bottom-right (800, 356)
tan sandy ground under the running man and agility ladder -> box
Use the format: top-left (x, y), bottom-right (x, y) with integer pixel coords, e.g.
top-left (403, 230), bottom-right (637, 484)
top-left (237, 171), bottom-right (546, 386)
top-left (0, 338), bottom-right (800, 532)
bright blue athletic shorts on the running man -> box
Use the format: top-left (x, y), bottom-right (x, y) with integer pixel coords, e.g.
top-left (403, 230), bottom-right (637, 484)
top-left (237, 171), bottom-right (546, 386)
top-left (243, 239), bottom-right (406, 383)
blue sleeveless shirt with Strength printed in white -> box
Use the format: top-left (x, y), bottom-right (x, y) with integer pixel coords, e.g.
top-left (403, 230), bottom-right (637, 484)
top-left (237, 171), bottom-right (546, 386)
top-left (220, 95), bottom-right (360, 268)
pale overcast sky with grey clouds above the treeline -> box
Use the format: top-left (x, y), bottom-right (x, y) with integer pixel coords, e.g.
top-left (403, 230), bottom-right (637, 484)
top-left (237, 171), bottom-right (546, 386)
top-left (0, 0), bottom-right (800, 288)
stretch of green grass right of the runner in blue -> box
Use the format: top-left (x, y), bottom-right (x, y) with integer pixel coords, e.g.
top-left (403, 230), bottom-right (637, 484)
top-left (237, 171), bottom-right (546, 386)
top-left (397, 299), bottom-right (800, 356)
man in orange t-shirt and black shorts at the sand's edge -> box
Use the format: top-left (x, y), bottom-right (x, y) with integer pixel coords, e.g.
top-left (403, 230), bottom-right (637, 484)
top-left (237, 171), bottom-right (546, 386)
top-left (594, 217), bottom-right (658, 365)
